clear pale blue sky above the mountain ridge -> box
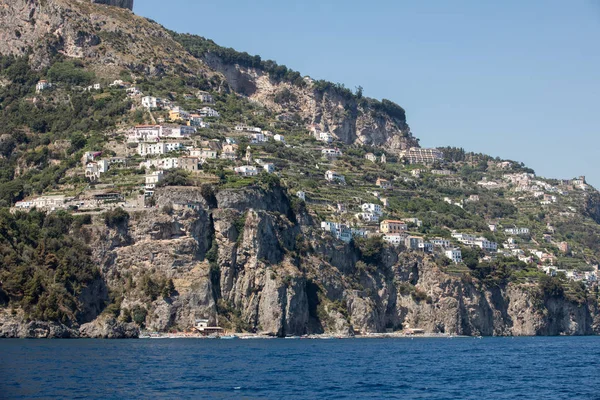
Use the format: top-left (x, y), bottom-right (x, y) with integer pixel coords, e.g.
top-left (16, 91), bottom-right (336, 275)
top-left (134, 0), bottom-right (600, 187)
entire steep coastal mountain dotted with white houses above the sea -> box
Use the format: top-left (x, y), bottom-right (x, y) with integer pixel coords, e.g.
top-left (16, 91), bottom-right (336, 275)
top-left (0, 0), bottom-right (600, 337)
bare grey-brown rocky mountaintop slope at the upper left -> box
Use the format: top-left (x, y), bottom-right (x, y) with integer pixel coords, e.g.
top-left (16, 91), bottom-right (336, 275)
top-left (0, 0), bottom-right (210, 79)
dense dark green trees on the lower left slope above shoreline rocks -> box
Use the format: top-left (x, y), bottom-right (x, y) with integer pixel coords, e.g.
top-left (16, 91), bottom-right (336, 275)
top-left (0, 209), bottom-right (100, 324)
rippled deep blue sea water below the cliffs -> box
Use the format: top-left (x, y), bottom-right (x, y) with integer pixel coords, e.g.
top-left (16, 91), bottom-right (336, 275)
top-left (0, 337), bottom-right (600, 400)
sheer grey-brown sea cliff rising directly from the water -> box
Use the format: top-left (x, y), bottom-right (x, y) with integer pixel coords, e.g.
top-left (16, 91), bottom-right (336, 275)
top-left (12, 187), bottom-right (584, 337)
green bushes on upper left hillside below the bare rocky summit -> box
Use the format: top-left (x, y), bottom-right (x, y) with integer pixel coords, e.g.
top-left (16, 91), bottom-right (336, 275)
top-left (0, 57), bottom-right (131, 207)
